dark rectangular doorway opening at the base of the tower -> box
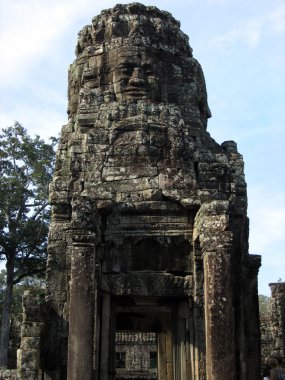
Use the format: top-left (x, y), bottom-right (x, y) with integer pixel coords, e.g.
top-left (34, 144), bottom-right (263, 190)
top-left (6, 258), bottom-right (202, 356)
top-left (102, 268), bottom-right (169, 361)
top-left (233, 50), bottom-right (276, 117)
top-left (112, 297), bottom-right (179, 380)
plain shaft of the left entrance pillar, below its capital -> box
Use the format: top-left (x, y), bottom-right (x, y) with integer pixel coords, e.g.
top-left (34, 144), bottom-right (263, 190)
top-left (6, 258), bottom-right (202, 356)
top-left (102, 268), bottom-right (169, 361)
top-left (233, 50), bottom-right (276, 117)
top-left (67, 243), bottom-right (95, 380)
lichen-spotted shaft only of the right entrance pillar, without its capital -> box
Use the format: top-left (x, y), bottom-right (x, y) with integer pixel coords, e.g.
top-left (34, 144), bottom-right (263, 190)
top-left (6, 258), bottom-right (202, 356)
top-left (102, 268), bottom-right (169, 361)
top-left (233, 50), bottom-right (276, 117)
top-left (204, 249), bottom-right (236, 380)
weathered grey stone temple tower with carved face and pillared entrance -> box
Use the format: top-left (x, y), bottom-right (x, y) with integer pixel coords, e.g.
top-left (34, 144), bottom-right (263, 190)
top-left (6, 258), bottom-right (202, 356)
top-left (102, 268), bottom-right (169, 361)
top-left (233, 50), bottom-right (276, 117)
top-left (22, 3), bottom-right (260, 380)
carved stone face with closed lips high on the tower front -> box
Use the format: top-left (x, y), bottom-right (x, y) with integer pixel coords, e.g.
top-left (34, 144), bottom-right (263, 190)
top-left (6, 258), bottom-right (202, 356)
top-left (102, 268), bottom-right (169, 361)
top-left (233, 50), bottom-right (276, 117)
top-left (113, 56), bottom-right (160, 101)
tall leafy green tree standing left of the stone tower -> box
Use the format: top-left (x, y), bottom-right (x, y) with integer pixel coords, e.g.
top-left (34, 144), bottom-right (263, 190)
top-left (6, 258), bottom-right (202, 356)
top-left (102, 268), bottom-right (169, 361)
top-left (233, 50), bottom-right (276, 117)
top-left (0, 122), bottom-right (57, 368)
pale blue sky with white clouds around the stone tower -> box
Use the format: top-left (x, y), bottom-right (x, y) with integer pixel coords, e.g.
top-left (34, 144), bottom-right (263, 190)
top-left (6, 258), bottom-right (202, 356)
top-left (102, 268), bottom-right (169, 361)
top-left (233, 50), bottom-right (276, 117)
top-left (0, 0), bottom-right (285, 296)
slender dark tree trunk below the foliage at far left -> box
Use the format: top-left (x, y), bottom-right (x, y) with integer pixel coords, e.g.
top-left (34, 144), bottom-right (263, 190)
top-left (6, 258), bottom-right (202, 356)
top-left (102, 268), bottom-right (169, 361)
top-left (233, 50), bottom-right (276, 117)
top-left (0, 257), bottom-right (15, 368)
